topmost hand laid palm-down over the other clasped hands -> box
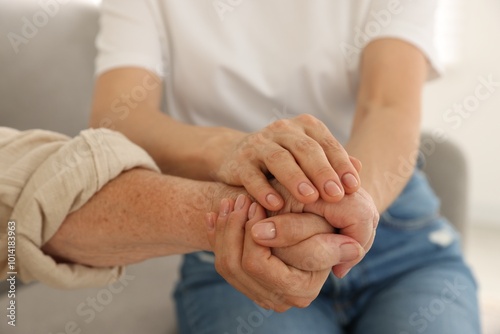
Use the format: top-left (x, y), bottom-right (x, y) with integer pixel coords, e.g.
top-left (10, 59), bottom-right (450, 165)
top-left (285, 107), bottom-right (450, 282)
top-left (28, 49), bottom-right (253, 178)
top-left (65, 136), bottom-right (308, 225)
top-left (212, 114), bottom-right (361, 211)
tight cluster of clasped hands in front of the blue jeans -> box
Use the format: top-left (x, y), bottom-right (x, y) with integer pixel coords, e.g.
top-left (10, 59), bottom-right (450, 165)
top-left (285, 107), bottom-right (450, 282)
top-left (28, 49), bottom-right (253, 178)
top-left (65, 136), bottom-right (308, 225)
top-left (207, 116), bottom-right (379, 312)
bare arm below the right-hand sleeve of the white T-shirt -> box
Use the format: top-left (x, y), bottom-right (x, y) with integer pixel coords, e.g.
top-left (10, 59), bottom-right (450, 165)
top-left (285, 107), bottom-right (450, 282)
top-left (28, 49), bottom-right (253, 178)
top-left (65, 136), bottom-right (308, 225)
top-left (346, 39), bottom-right (427, 212)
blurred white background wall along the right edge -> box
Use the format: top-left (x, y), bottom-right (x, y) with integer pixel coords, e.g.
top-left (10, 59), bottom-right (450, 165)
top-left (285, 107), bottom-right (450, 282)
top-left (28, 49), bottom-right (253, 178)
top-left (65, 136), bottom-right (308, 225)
top-left (423, 0), bottom-right (500, 229)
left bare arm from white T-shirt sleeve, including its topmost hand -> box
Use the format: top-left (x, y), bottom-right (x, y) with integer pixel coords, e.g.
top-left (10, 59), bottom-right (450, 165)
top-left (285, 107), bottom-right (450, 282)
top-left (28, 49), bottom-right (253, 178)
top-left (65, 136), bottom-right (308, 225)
top-left (90, 67), bottom-right (360, 210)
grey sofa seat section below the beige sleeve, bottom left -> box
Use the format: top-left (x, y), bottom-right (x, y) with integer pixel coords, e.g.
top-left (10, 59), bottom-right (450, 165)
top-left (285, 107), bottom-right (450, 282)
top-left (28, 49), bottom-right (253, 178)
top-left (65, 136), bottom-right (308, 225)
top-left (0, 256), bottom-right (180, 334)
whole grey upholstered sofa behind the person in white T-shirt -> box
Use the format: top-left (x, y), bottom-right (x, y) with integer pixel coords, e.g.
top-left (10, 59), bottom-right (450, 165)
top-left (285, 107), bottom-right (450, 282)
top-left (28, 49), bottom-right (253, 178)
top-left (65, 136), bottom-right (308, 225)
top-left (0, 0), bottom-right (467, 334)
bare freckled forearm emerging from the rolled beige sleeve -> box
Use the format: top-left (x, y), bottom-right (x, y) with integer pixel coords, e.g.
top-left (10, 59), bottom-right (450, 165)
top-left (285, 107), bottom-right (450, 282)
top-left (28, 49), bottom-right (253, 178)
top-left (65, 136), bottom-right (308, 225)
top-left (43, 169), bottom-right (242, 267)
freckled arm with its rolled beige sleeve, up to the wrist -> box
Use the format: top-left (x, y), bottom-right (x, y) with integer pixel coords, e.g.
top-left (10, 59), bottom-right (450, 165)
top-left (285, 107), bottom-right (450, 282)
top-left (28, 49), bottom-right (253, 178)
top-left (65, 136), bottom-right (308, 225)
top-left (0, 127), bottom-right (240, 288)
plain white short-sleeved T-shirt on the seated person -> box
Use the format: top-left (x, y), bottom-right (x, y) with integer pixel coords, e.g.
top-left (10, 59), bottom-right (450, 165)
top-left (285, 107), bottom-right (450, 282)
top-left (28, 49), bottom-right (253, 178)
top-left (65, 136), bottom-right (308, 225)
top-left (96, 0), bottom-right (437, 142)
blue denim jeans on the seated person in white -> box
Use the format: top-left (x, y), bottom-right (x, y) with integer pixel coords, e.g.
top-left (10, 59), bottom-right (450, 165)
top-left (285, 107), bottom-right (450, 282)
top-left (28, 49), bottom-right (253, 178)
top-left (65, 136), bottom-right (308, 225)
top-left (175, 170), bottom-right (480, 334)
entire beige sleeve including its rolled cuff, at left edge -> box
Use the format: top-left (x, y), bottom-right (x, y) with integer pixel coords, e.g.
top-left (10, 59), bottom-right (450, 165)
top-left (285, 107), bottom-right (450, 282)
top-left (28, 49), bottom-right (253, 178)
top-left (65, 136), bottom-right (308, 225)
top-left (0, 127), bottom-right (159, 288)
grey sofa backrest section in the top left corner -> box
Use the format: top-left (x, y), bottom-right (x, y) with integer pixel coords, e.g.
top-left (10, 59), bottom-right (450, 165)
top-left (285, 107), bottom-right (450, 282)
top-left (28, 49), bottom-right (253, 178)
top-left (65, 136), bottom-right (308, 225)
top-left (0, 0), bottom-right (98, 135)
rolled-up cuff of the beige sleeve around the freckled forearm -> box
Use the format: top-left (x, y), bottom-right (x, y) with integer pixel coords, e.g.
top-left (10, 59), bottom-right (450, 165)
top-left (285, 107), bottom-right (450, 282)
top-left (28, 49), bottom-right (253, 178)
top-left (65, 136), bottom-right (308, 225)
top-left (11, 129), bottom-right (159, 288)
